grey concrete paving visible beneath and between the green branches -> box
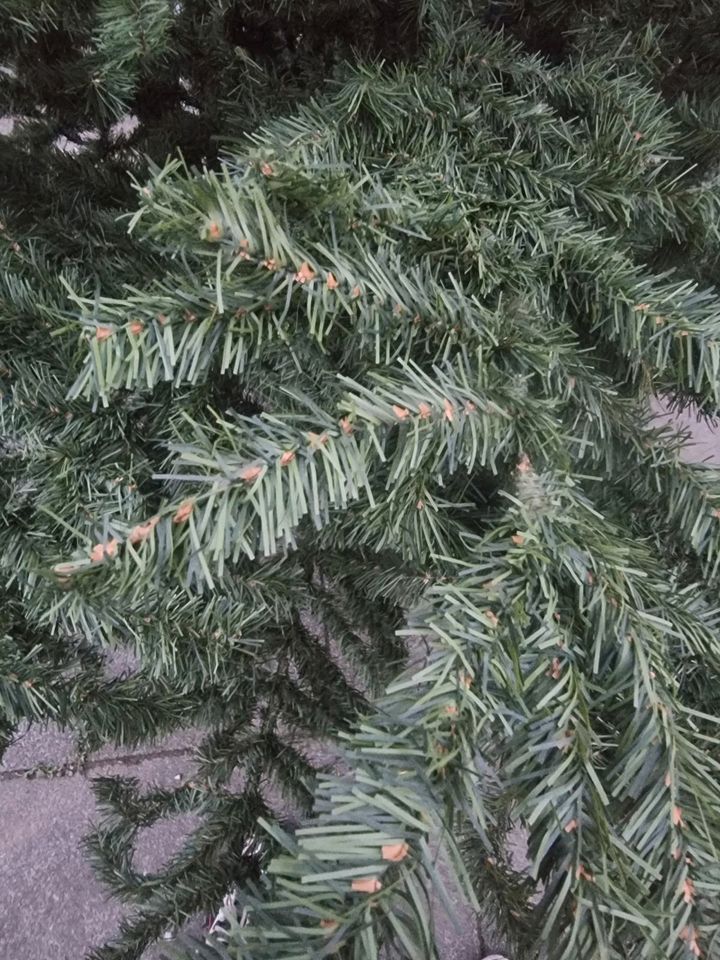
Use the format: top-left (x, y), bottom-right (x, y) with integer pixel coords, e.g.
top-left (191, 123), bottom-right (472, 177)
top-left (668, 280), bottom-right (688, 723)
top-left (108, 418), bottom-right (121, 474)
top-left (0, 400), bottom-right (720, 960)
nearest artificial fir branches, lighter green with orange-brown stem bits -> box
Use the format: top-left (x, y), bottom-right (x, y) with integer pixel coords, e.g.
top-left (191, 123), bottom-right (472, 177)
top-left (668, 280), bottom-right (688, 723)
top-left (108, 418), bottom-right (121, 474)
top-left (50, 5), bottom-right (720, 958)
